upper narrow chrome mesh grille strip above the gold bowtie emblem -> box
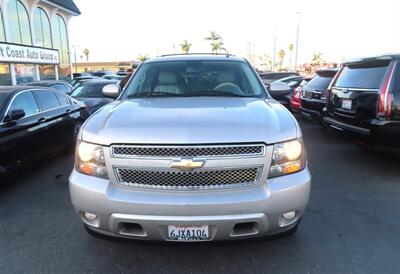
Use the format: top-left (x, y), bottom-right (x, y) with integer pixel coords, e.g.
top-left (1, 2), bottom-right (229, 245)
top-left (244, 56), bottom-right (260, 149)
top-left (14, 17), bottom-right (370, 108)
top-left (111, 144), bottom-right (265, 158)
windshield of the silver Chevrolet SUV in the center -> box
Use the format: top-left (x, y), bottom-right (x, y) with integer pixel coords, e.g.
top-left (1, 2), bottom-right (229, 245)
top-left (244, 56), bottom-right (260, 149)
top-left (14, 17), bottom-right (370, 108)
top-left (123, 60), bottom-right (265, 98)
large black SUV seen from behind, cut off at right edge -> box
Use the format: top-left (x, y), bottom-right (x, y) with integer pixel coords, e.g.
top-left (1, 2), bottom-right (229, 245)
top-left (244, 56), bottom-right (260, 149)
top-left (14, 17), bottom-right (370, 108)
top-left (323, 54), bottom-right (400, 148)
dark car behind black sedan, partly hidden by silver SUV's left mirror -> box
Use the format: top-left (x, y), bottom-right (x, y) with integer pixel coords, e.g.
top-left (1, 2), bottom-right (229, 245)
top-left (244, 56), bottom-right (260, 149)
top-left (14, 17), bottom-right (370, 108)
top-left (71, 80), bottom-right (118, 114)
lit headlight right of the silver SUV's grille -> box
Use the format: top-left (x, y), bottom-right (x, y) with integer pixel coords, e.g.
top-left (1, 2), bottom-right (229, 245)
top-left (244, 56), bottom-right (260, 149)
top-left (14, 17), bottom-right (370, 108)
top-left (268, 139), bottom-right (306, 178)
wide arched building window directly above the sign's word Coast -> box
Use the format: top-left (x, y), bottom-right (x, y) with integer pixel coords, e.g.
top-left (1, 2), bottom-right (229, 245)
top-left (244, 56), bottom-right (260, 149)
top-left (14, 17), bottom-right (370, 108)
top-left (6, 0), bottom-right (32, 45)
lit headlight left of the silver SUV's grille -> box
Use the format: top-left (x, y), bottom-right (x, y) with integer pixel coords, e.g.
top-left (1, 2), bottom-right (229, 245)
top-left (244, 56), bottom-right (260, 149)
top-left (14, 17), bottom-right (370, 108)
top-left (75, 141), bottom-right (108, 178)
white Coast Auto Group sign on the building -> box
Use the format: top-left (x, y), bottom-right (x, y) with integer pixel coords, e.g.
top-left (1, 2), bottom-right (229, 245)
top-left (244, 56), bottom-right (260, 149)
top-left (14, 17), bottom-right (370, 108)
top-left (0, 43), bottom-right (60, 65)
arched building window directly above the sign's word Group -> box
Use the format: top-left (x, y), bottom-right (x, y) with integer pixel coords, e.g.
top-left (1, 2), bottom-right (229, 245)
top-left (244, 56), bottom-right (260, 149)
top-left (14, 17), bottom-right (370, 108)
top-left (33, 8), bottom-right (52, 48)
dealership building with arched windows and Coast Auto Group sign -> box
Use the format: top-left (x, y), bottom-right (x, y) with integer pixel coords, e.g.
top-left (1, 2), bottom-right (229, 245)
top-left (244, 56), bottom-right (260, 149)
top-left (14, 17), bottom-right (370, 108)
top-left (0, 0), bottom-right (80, 86)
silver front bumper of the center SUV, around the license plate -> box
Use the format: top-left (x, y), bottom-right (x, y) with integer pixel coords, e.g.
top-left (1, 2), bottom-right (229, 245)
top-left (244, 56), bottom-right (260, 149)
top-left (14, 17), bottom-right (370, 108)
top-left (69, 169), bottom-right (311, 240)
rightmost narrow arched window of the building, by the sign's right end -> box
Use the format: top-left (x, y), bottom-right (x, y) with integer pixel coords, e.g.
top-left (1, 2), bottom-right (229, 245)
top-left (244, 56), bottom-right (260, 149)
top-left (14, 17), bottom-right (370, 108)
top-left (53, 15), bottom-right (69, 65)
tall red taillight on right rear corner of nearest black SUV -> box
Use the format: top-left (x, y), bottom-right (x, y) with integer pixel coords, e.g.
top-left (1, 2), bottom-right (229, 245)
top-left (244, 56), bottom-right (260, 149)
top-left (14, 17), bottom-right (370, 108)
top-left (377, 62), bottom-right (394, 118)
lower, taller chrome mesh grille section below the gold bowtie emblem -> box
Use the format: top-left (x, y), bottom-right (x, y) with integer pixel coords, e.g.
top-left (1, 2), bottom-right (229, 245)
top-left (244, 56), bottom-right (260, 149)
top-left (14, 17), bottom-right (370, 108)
top-left (115, 167), bottom-right (262, 190)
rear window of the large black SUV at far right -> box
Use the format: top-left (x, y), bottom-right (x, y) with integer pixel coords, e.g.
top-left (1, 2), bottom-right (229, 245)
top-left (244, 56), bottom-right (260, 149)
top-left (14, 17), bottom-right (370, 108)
top-left (335, 61), bottom-right (389, 89)
